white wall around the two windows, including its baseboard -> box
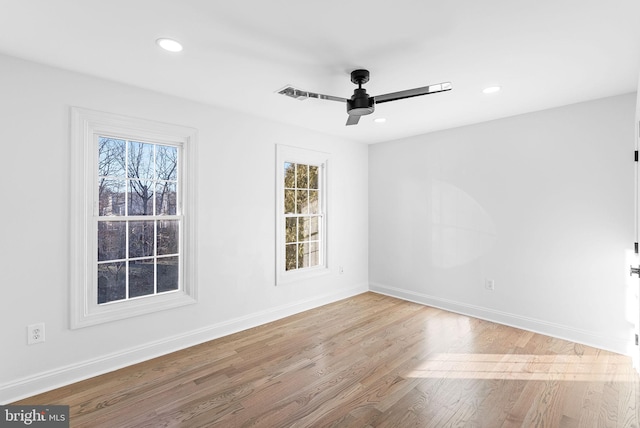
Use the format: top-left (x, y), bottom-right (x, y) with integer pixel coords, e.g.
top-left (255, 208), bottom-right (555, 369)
top-left (0, 56), bottom-right (368, 403)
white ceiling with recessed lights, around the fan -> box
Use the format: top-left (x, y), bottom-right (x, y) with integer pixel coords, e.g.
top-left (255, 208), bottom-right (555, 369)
top-left (0, 0), bottom-right (640, 143)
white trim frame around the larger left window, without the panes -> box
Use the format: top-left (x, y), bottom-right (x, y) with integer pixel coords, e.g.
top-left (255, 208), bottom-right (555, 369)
top-left (70, 107), bottom-right (197, 329)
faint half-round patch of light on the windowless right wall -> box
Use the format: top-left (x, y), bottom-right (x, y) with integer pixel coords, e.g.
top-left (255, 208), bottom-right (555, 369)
top-left (429, 180), bottom-right (497, 268)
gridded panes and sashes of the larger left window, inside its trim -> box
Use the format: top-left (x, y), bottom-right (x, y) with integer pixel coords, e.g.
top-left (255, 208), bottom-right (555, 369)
top-left (96, 136), bottom-right (182, 304)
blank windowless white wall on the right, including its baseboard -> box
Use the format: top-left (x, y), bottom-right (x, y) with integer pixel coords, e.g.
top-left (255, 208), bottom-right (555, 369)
top-left (369, 94), bottom-right (636, 353)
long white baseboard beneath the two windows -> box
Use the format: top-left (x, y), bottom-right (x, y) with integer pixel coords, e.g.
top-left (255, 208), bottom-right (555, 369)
top-left (0, 284), bottom-right (369, 404)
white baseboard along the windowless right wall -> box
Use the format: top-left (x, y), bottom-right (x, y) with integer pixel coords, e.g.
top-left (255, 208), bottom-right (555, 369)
top-left (369, 283), bottom-right (629, 355)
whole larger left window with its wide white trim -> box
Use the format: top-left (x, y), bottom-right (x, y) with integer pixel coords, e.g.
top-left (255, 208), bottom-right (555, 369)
top-left (71, 108), bottom-right (196, 328)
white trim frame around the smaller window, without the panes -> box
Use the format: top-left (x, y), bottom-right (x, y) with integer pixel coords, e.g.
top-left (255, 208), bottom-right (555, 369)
top-left (275, 144), bottom-right (332, 285)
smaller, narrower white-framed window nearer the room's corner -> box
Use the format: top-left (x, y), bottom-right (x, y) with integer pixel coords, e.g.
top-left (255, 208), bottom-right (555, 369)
top-left (276, 145), bottom-right (328, 284)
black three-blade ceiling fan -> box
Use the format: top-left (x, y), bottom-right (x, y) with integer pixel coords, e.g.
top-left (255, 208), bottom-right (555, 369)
top-left (278, 69), bottom-right (453, 126)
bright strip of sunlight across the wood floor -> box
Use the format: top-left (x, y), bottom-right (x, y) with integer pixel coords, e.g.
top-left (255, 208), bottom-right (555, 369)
top-left (403, 354), bottom-right (630, 382)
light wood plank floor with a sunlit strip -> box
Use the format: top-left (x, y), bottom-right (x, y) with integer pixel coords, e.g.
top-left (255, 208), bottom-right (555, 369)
top-left (16, 293), bottom-right (640, 428)
